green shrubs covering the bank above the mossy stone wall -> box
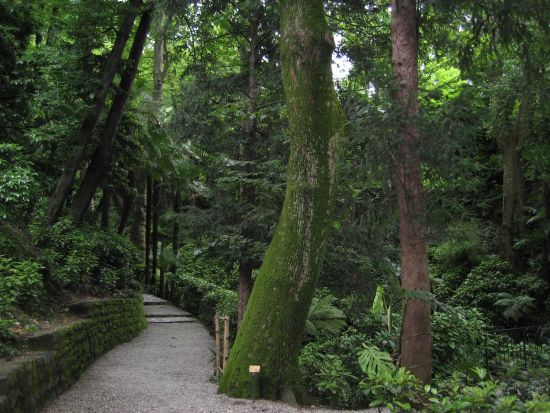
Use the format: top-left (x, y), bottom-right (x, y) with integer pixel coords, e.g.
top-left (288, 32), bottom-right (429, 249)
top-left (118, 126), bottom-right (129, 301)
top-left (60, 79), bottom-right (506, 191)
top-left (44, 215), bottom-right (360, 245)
top-left (0, 219), bottom-right (142, 357)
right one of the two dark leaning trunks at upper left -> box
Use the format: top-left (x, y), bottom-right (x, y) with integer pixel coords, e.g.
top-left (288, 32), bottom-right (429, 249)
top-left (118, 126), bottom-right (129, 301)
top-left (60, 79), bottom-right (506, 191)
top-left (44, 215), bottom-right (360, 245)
top-left (71, 9), bottom-right (152, 223)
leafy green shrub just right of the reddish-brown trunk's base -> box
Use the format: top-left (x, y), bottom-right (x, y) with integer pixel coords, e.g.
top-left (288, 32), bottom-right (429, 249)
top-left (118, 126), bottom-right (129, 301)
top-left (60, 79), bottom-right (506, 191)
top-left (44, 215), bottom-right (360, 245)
top-left (432, 307), bottom-right (490, 374)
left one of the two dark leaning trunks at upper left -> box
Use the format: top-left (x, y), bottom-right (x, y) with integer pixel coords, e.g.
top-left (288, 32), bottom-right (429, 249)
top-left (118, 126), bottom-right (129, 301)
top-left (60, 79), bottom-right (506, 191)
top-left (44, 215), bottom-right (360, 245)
top-left (48, 0), bottom-right (141, 225)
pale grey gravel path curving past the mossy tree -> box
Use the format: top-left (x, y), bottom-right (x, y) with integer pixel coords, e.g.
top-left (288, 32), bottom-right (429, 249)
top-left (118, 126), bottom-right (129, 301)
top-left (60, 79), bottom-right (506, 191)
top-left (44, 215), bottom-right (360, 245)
top-left (44, 296), bottom-right (386, 413)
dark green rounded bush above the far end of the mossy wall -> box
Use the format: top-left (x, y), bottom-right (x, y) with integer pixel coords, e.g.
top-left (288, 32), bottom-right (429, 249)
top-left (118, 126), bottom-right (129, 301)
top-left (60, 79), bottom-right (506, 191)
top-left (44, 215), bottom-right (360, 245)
top-left (40, 219), bottom-right (140, 293)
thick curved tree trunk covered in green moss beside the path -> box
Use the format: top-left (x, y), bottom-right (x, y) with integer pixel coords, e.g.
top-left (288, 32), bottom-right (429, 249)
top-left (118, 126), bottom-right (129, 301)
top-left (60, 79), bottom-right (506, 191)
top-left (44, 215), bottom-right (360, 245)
top-left (220, 0), bottom-right (343, 400)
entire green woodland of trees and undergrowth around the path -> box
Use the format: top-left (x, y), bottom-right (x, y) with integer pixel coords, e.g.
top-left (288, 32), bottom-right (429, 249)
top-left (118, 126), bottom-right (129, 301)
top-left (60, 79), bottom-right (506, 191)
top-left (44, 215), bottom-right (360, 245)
top-left (0, 0), bottom-right (550, 412)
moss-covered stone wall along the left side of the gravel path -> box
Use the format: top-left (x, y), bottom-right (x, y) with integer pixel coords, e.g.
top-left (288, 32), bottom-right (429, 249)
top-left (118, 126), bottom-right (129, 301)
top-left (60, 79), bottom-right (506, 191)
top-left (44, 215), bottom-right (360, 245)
top-left (0, 295), bottom-right (147, 413)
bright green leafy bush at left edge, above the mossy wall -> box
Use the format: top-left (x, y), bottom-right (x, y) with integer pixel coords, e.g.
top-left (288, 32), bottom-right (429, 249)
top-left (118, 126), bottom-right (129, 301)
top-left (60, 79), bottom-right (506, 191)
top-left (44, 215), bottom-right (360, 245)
top-left (0, 256), bottom-right (43, 312)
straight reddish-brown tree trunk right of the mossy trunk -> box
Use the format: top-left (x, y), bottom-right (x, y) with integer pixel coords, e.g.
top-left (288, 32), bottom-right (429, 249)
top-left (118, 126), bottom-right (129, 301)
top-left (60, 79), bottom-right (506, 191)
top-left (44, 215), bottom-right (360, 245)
top-left (391, 0), bottom-right (432, 383)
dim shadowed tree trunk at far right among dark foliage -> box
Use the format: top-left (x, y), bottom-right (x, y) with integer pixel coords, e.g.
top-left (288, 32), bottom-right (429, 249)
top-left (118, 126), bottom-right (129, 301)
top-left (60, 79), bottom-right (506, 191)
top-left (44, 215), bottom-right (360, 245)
top-left (499, 95), bottom-right (530, 270)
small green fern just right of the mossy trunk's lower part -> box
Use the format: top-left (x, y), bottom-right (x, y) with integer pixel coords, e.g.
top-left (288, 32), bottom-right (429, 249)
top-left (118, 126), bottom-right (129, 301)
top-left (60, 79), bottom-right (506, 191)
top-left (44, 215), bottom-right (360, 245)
top-left (306, 295), bottom-right (347, 337)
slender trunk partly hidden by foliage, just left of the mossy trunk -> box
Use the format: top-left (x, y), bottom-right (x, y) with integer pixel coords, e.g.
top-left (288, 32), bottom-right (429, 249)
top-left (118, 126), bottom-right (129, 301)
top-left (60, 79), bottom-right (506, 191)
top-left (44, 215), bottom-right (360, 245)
top-left (237, 4), bottom-right (260, 327)
